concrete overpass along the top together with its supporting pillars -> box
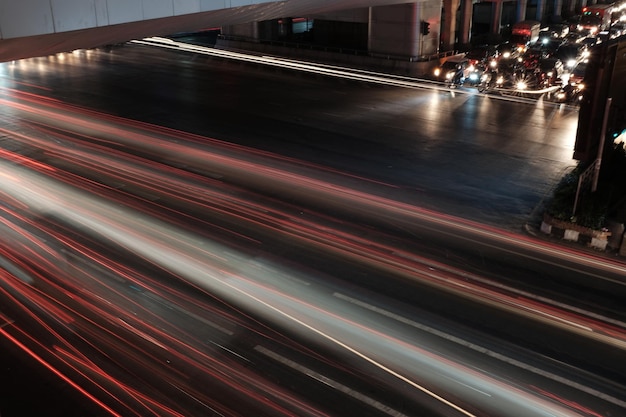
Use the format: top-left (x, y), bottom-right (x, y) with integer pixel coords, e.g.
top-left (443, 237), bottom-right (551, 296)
top-left (0, 0), bottom-right (586, 62)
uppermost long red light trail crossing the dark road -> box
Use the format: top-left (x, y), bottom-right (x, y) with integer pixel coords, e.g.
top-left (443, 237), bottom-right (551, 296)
top-left (0, 88), bottom-right (608, 284)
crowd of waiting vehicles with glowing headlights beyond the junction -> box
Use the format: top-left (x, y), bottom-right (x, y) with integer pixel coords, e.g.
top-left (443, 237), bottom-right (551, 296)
top-left (434, 11), bottom-right (626, 104)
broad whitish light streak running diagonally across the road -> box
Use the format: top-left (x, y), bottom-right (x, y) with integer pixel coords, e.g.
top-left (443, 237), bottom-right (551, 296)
top-left (0, 162), bottom-right (584, 416)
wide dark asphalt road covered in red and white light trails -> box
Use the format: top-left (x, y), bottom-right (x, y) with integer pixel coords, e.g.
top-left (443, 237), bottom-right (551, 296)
top-left (1, 37), bottom-right (625, 415)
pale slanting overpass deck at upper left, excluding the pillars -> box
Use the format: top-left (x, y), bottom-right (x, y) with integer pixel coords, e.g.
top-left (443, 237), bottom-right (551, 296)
top-left (0, 0), bottom-right (414, 62)
